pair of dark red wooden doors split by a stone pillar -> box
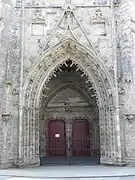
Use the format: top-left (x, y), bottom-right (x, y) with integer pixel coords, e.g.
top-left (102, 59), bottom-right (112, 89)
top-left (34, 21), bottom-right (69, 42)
top-left (48, 120), bottom-right (90, 156)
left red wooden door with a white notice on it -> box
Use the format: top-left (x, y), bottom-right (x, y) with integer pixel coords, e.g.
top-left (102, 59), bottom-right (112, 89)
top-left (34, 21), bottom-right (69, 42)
top-left (48, 120), bottom-right (66, 156)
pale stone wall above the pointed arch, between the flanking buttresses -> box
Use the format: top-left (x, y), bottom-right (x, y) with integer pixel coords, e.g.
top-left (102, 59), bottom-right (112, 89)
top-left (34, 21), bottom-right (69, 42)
top-left (24, 0), bottom-right (114, 81)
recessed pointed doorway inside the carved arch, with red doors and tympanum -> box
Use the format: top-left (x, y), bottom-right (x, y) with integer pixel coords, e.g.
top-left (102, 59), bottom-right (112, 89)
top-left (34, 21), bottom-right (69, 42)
top-left (40, 60), bottom-right (100, 164)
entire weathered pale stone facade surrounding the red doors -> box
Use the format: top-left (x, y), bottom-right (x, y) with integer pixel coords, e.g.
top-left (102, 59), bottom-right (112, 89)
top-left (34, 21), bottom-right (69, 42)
top-left (0, 0), bottom-right (135, 168)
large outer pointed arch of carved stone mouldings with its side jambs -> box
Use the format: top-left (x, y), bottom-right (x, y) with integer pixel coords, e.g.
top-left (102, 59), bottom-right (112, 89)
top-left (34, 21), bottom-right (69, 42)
top-left (19, 38), bottom-right (122, 165)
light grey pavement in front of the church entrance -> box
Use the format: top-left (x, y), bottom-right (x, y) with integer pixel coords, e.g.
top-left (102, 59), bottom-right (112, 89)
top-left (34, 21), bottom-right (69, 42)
top-left (0, 165), bottom-right (135, 180)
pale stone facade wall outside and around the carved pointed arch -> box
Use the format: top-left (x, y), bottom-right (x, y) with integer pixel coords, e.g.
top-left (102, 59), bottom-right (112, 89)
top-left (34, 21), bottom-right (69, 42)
top-left (0, 0), bottom-right (135, 167)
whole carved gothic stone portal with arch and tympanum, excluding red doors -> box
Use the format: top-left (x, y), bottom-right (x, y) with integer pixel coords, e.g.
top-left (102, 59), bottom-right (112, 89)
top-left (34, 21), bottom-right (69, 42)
top-left (19, 38), bottom-right (122, 165)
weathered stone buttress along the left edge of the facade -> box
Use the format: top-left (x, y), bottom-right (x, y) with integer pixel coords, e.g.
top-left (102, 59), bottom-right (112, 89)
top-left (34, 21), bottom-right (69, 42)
top-left (0, 0), bottom-right (20, 167)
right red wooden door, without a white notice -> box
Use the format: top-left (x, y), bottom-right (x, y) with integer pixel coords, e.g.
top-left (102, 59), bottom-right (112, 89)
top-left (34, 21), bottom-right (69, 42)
top-left (72, 120), bottom-right (90, 156)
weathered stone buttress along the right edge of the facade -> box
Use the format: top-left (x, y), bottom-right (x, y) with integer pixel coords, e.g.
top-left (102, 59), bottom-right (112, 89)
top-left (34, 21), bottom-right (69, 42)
top-left (115, 0), bottom-right (135, 163)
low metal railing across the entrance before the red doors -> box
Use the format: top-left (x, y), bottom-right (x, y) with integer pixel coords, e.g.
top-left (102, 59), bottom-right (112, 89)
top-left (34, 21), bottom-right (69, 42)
top-left (42, 137), bottom-right (100, 164)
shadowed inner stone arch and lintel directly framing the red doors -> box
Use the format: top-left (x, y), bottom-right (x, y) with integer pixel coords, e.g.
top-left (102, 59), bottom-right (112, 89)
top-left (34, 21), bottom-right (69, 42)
top-left (40, 82), bottom-right (99, 158)
